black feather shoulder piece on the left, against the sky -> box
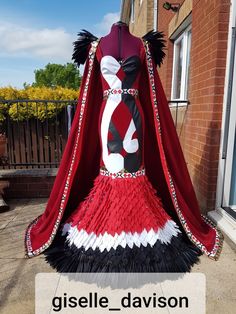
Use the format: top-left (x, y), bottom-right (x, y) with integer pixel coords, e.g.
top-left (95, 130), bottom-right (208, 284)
top-left (72, 29), bottom-right (98, 66)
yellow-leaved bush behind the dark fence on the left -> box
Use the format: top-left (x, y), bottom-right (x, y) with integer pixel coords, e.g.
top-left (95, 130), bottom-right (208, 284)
top-left (0, 86), bottom-right (79, 121)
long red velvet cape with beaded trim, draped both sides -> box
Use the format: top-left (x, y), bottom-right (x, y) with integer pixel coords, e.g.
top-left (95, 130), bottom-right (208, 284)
top-left (25, 39), bottom-right (223, 260)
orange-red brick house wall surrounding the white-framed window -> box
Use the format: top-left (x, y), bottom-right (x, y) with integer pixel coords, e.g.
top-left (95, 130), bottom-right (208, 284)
top-left (158, 0), bottom-right (230, 212)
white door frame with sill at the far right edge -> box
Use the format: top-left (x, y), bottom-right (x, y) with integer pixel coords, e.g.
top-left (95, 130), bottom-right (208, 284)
top-left (207, 0), bottom-right (236, 244)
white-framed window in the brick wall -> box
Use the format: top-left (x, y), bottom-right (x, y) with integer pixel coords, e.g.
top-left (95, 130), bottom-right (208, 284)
top-left (171, 26), bottom-right (191, 101)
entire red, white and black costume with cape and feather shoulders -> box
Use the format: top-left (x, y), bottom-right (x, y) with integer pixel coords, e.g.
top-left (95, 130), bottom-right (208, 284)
top-left (26, 25), bottom-right (222, 272)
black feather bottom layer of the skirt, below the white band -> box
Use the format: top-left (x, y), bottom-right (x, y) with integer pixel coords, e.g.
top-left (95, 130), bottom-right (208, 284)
top-left (44, 234), bottom-right (202, 273)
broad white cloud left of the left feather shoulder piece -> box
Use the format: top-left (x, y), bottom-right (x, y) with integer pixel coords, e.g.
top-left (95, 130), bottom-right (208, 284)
top-left (0, 22), bottom-right (73, 62)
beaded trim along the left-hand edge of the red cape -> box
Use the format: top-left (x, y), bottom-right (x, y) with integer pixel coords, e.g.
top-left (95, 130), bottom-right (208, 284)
top-left (25, 38), bottom-right (99, 257)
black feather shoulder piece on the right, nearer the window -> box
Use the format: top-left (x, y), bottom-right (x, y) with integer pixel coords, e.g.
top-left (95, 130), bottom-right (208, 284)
top-left (142, 30), bottom-right (166, 66)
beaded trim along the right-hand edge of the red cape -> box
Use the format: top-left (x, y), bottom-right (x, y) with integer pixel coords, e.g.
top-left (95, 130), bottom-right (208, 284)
top-left (143, 40), bottom-right (224, 260)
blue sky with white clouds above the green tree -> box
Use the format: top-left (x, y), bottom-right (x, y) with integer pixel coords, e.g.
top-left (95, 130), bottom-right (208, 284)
top-left (0, 0), bottom-right (121, 88)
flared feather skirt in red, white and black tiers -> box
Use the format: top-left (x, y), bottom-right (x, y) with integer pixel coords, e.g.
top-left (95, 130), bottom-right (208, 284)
top-left (44, 171), bottom-right (201, 272)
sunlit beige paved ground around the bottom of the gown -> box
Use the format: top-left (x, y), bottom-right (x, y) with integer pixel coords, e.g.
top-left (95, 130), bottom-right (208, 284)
top-left (0, 199), bottom-right (236, 314)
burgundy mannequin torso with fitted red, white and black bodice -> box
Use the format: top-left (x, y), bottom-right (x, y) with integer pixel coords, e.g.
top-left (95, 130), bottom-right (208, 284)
top-left (97, 22), bottom-right (144, 173)
